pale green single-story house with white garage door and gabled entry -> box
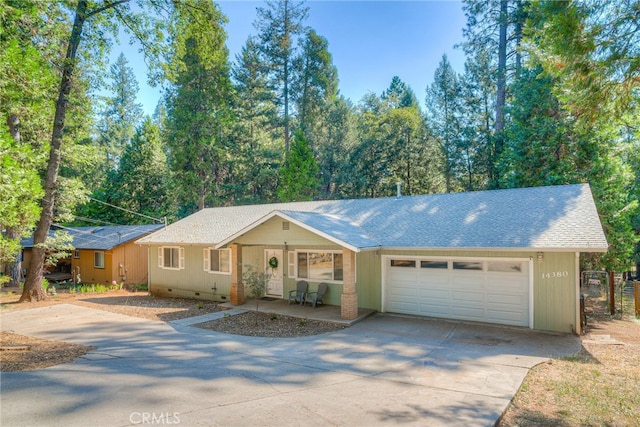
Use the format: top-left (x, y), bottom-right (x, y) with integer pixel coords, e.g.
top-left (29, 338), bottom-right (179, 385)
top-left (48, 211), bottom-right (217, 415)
top-left (137, 184), bottom-right (608, 333)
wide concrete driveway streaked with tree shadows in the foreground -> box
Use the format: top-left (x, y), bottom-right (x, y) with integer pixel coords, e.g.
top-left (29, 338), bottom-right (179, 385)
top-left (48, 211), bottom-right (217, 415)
top-left (0, 304), bottom-right (580, 427)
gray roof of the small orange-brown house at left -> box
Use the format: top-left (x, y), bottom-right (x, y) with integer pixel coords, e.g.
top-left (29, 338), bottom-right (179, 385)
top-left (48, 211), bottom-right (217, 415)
top-left (21, 224), bottom-right (164, 251)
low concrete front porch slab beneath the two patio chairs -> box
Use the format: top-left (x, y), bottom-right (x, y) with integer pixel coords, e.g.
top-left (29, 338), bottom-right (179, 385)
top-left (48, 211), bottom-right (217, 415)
top-left (219, 298), bottom-right (376, 326)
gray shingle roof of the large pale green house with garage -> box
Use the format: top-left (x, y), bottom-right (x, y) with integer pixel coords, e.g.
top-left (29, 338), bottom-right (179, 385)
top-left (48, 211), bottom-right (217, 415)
top-left (138, 184), bottom-right (608, 252)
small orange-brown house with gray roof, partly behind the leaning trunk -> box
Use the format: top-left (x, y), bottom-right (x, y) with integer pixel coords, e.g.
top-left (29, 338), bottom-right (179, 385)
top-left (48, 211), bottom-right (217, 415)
top-left (22, 224), bottom-right (164, 284)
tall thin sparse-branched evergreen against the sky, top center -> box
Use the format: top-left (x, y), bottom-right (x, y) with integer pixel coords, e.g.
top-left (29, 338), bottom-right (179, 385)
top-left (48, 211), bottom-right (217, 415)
top-left (254, 0), bottom-right (309, 152)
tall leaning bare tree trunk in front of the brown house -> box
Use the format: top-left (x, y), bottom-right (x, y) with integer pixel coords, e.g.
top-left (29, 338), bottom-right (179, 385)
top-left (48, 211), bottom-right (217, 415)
top-left (19, 0), bottom-right (87, 302)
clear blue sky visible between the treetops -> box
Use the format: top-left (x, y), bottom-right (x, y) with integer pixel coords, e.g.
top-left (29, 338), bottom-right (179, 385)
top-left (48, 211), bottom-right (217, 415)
top-left (117, 0), bottom-right (466, 114)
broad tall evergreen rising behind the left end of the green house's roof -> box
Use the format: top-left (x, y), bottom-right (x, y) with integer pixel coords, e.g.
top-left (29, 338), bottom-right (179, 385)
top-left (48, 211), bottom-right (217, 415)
top-left (167, 0), bottom-right (232, 215)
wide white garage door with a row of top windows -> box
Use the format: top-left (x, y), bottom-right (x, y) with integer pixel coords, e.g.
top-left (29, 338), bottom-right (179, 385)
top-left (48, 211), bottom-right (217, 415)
top-left (383, 257), bottom-right (529, 326)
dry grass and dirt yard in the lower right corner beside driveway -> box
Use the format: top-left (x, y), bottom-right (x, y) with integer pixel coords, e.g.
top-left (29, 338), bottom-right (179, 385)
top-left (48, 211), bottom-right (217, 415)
top-left (499, 287), bottom-right (640, 427)
